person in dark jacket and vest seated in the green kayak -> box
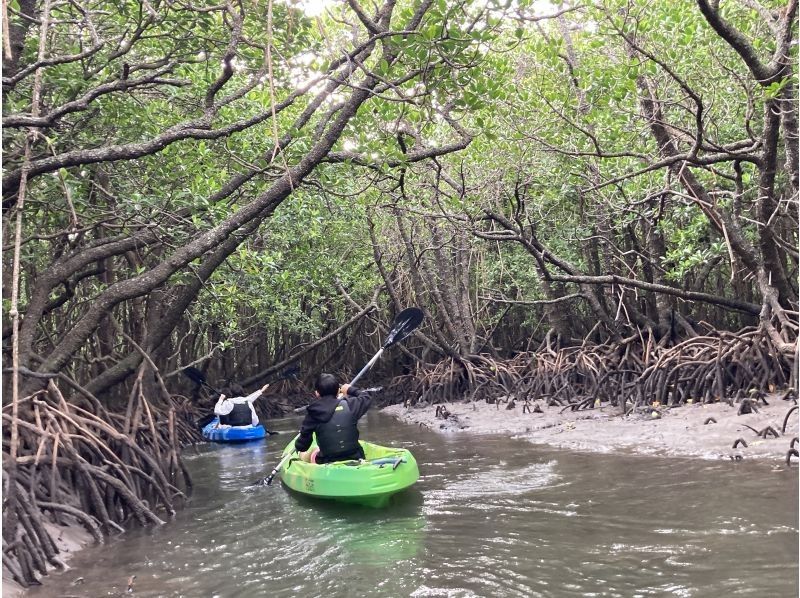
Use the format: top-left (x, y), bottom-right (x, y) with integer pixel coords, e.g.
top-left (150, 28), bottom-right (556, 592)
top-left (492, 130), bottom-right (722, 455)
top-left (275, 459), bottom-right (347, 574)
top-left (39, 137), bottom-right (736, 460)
top-left (294, 374), bottom-right (372, 464)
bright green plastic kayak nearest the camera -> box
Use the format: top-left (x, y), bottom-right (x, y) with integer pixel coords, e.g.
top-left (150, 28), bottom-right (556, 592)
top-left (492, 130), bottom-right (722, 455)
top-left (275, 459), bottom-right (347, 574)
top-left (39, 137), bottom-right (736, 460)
top-left (281, 440), bottom-right (419, 507)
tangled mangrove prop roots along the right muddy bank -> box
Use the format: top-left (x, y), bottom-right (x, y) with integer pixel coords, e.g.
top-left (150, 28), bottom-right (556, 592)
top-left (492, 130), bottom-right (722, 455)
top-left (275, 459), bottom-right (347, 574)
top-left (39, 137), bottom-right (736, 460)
top-left (400, 328), bottom-right (794, 422)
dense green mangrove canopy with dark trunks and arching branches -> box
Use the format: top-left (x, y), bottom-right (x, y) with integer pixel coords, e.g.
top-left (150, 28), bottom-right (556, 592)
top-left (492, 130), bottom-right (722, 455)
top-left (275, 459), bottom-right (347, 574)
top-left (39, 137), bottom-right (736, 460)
top-left (3, 0), bottom-right (798, 394)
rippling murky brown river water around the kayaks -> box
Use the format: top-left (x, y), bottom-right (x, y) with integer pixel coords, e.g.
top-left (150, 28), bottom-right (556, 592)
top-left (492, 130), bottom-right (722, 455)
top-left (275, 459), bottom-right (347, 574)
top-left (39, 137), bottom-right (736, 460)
top-left (29, 413), bottom-right (798, 598)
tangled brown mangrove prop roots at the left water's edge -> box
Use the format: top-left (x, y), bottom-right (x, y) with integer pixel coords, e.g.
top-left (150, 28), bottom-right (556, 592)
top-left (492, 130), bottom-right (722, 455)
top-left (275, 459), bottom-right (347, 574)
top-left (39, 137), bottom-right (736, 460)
top-left (2, 381), bottom-right (200, 587)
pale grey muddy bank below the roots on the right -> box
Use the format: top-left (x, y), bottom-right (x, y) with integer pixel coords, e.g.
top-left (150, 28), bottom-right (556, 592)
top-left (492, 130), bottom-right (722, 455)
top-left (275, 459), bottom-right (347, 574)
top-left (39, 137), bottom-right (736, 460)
top-left (383, 394), bottom-right (798, 463)
